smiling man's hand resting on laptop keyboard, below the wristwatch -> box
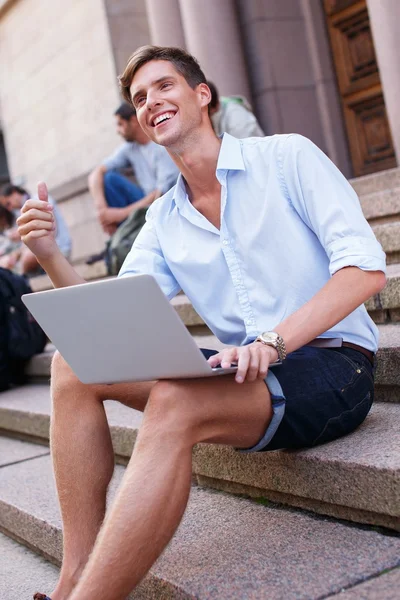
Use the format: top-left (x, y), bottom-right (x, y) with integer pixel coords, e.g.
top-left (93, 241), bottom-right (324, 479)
top-left (208, 342), bottom-right (278, 383)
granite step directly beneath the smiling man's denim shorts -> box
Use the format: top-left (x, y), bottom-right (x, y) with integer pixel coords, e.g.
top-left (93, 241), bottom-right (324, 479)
top-left (0, 384), bottom-right (400, 530)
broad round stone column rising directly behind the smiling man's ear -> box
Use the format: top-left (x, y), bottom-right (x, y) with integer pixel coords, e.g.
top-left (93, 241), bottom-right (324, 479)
top-left (180, 0), bottom-right (250, 99)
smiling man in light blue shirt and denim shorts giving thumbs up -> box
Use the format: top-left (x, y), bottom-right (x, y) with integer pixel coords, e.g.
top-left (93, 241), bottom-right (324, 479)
top-left (18, 46), bottom-right (385, 600)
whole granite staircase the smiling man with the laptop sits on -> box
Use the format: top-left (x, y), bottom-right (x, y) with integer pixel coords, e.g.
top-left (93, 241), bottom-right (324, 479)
top-left (0, 169), bottom-right (400, 600)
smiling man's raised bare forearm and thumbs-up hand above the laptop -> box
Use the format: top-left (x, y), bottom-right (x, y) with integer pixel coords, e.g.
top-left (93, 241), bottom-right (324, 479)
top-left (17, 183), bottom-right (85, 287)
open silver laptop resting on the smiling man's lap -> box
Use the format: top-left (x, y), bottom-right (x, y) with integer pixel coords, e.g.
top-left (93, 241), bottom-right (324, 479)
top-left (22, 275), bottom-right (236, 383)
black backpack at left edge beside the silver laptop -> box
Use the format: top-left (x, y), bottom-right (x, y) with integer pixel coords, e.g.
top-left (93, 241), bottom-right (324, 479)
top-left (0, 268), bottom-right (47, 391)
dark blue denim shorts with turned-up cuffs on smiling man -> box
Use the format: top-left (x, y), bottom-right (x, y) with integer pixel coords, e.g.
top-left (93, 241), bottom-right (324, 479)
top-left (203, 346), bottom-right (374, 452)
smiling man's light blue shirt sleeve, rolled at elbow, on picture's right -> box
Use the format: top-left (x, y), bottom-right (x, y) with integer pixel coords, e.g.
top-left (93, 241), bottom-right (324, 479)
top-left (281, 134), bottom-right (386, 275)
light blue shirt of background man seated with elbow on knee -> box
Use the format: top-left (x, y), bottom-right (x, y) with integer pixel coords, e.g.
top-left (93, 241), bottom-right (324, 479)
top-left (103, 142), bottom-right (179, 196)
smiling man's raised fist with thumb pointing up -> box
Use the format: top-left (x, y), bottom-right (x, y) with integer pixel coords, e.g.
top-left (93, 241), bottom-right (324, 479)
top-left (17, 182), bottom-right (57, 260)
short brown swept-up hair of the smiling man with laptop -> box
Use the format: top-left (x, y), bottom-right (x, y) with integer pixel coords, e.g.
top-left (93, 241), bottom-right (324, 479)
top-left (118, 46), bottom-right (207, 105)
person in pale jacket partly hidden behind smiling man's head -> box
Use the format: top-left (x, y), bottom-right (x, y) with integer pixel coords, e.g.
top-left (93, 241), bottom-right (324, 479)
top-left (207, 81), bottom-right (265, 138)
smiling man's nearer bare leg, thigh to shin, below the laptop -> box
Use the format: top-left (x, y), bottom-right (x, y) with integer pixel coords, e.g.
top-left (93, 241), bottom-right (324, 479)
top-left (69, 376), bottom-right (272, 600)
